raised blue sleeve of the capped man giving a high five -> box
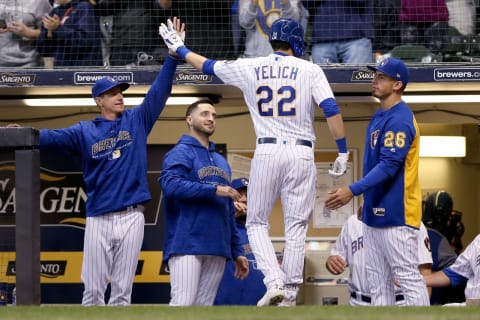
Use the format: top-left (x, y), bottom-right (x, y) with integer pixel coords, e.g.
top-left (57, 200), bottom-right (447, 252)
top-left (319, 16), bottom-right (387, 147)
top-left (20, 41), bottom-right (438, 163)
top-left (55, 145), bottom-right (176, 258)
top-left (137, 55), bottom-right (178, 134)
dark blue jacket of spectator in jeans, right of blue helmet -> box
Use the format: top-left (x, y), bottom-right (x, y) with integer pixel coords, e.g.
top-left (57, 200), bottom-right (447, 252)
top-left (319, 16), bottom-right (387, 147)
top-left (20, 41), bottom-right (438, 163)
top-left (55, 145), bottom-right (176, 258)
top-left (302, 0), bottom-right (373, 44)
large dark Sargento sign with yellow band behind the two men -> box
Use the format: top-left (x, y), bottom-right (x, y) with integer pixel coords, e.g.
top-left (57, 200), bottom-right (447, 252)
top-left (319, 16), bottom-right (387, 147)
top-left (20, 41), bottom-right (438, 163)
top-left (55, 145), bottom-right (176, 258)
top-left (0, 144), bottom-right (226, 304)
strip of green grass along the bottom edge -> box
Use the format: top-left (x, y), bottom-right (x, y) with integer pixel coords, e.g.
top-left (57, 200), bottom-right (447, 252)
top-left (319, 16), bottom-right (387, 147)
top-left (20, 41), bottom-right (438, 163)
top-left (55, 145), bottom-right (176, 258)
top-left (0, 305), bottom-right (480, 320)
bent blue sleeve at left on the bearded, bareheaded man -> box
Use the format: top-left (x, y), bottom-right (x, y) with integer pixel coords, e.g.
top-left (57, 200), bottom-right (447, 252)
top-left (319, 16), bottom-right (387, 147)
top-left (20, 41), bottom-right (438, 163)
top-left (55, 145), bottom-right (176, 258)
top-left (158, 148), bottom-right (217, 200)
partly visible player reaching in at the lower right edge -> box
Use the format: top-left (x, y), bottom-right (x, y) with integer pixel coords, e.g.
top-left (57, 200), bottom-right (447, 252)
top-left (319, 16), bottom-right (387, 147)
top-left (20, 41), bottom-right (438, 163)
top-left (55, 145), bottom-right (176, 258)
top-left (424, 234), bottom-right (480, 300)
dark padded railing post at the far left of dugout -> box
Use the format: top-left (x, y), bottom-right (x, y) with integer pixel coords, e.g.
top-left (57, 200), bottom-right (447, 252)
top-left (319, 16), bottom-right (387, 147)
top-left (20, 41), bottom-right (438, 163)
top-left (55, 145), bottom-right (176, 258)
top-left (0, 127), bottom-right (40, 305)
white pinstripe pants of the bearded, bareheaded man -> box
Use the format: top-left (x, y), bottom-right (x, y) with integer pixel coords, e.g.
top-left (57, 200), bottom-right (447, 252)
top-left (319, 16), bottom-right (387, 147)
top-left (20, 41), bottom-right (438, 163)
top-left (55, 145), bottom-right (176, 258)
top-left (168, 255), bottom-right (226, 306)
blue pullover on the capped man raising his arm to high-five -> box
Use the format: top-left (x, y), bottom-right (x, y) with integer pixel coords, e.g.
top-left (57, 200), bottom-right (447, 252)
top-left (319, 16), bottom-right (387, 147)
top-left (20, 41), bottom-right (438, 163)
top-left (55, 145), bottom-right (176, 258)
top-left (40, 56), bottom-right (177, 217)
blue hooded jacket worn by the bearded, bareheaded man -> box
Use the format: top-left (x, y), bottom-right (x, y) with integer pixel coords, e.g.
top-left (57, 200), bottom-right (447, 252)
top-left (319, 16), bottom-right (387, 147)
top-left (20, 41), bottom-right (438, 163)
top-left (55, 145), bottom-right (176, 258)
top-left (158, 135), bottom-right (242, 262)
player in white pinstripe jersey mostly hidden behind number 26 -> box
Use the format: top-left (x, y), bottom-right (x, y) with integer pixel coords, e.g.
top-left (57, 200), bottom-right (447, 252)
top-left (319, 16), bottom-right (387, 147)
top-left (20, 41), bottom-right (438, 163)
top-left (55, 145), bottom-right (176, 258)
top-left (325, 214), bottom-right (432, 306)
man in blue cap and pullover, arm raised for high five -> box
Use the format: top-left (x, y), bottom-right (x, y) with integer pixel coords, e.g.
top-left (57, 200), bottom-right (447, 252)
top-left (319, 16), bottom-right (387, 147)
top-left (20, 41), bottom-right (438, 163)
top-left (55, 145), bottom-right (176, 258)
top-left (40, 50), bottom-right (177, 306)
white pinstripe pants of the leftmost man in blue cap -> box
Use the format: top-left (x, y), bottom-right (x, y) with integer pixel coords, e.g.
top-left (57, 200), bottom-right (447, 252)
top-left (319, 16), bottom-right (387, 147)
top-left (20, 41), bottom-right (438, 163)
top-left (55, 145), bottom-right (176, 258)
top-left (82, 206), bottom-right (145, 306)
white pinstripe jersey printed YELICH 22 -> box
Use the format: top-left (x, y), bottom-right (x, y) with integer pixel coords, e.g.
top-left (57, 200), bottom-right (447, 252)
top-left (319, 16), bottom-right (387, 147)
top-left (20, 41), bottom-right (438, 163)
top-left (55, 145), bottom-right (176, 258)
top-left (214, 54), bottom-right (334, 141)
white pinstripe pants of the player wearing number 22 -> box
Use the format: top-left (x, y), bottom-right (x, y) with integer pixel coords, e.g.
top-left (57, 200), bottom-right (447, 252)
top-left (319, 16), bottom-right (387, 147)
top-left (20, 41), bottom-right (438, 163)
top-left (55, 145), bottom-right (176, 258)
top-left (246, 144), bottom-right (316, 288)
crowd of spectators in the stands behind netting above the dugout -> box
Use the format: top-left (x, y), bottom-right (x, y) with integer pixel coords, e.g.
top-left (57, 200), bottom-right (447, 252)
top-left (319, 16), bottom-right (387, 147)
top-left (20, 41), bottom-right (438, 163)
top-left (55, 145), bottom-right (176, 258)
top-left (0, 0), bottom-right (480, 68)
